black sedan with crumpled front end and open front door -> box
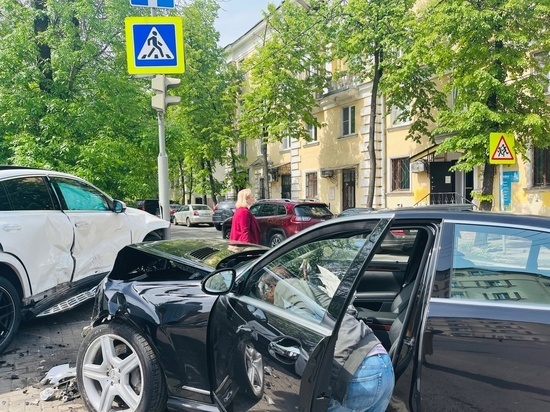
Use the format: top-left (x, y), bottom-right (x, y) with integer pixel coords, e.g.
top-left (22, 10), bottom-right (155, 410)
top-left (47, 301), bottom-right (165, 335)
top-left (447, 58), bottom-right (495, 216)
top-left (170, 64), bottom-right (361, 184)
top-left (76, 209), bottom-right (550, 412)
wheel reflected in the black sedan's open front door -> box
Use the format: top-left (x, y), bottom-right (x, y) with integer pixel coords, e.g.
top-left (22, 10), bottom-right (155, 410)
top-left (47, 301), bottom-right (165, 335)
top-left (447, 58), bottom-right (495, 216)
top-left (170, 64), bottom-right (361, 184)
top-left (236, 340), bottom-right (264, 401)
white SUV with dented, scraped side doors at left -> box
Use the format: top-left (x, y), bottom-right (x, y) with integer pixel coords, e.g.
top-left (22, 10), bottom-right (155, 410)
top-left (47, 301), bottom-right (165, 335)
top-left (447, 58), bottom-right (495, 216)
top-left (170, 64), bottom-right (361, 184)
top-left (0, 166), bottom-right (169, 353)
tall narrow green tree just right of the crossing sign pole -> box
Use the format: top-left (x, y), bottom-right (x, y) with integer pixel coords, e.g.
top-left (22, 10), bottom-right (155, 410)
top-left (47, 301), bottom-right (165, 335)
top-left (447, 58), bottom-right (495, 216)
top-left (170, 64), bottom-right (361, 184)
top-left (170, 0), bottom-right (244, 203)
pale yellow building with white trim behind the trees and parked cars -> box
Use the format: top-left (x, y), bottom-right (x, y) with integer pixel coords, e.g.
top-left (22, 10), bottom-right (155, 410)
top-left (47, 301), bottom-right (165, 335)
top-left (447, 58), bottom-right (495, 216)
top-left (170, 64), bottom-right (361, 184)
top-left (225, 8), bottom-right (550, 215)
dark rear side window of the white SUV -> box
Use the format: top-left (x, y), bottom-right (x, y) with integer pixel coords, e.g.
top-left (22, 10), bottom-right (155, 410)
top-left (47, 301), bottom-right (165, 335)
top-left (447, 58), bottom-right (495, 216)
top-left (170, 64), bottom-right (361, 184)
top-left (0, 176), bottom-right (56, 210)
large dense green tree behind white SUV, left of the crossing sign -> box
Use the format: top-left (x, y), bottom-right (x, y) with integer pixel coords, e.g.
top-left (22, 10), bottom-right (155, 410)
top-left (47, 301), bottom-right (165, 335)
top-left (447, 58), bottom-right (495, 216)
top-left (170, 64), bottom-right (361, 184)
top-left (0, 0), bottom-right (160, 198)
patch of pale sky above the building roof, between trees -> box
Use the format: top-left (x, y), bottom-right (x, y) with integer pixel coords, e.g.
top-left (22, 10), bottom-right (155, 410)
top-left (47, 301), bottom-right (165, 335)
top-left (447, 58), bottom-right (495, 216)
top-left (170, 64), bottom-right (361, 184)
top-left (215, 0), bottom-right (281, 47)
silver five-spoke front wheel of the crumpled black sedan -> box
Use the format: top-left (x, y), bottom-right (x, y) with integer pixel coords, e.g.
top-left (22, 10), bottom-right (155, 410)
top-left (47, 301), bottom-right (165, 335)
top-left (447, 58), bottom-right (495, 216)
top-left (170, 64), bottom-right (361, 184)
top-left (76, 322), bottom-right (167, 412)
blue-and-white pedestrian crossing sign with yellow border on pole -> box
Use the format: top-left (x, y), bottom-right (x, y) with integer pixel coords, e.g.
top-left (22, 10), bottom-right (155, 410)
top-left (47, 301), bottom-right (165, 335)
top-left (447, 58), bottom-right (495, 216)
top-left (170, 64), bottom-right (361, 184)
top-left (125, 16), bottom-right (185, 74)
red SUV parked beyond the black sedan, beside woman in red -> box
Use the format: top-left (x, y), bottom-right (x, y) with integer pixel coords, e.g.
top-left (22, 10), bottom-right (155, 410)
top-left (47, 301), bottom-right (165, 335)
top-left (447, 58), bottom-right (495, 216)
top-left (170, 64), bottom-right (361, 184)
top-left (222, 199), bottom-right (334, 247)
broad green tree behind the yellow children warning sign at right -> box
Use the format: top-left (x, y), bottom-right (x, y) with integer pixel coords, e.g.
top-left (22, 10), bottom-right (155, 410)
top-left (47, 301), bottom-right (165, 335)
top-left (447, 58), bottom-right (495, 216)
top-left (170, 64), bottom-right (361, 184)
top-left (408, 0), bottom-right (550, 210)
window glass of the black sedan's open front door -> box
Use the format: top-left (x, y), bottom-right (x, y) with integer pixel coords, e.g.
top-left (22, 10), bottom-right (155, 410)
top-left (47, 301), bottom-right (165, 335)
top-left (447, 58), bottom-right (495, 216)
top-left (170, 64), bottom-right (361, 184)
top-left (245, 235), bottom-right (366, 323)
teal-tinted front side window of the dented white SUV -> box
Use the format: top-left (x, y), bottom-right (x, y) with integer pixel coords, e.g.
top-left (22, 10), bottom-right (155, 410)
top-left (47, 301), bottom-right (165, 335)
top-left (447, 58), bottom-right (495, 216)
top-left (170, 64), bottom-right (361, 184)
top-left (52, 178), bottom-right (110, 211)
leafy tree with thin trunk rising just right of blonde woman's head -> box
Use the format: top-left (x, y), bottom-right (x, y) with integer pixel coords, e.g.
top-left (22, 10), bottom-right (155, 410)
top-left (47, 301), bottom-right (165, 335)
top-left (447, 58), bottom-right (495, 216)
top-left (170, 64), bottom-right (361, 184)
top-left (239, 1), bottom-right (328, 198)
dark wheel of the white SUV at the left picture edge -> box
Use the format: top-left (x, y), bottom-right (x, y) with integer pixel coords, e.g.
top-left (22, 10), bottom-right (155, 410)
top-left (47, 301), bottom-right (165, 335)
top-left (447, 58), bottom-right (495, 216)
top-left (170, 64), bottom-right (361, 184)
top-left (0, 277), bottom-right (21, 353)
